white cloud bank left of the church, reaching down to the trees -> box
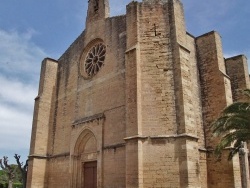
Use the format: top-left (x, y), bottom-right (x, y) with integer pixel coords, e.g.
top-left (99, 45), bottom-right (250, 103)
top-left (0, 29), bottom-right (46, 157)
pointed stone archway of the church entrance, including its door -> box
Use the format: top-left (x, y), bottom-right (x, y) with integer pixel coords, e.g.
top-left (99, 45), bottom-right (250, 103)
top-left (72, 129), bottom-right (97, 188)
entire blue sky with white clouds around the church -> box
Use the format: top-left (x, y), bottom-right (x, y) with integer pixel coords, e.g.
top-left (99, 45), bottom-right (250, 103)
top-left (0, 0), bottom-right (250, 162)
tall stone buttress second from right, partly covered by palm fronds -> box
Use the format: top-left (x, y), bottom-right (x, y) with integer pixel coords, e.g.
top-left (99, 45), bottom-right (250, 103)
top-left (196, 31), bottom-right (241, 188)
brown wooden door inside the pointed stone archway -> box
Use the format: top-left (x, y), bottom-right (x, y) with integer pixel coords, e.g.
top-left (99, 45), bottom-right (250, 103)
top-left (83, 161), bottom-right (97, 188)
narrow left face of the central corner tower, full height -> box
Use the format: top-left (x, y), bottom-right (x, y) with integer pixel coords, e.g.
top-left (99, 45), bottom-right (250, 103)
top-left (125, 2), bottom-right (143, 188)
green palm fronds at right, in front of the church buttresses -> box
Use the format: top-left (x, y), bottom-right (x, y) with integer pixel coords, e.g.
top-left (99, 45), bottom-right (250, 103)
top-left (211, 89), bottom-right (250, 160)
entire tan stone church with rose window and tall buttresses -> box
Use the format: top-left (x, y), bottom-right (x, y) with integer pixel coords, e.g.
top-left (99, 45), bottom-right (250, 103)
top-left (27, 0), bottom-right (250, 188)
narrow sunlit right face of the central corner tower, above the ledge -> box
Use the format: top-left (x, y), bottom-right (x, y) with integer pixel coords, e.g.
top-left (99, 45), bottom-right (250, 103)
top-left (169, 1), bottom-right (197, 135)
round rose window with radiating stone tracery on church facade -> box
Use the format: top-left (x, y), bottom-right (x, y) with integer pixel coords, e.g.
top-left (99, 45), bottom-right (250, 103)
top-left (84, 43), bottom-right (106, 77)
